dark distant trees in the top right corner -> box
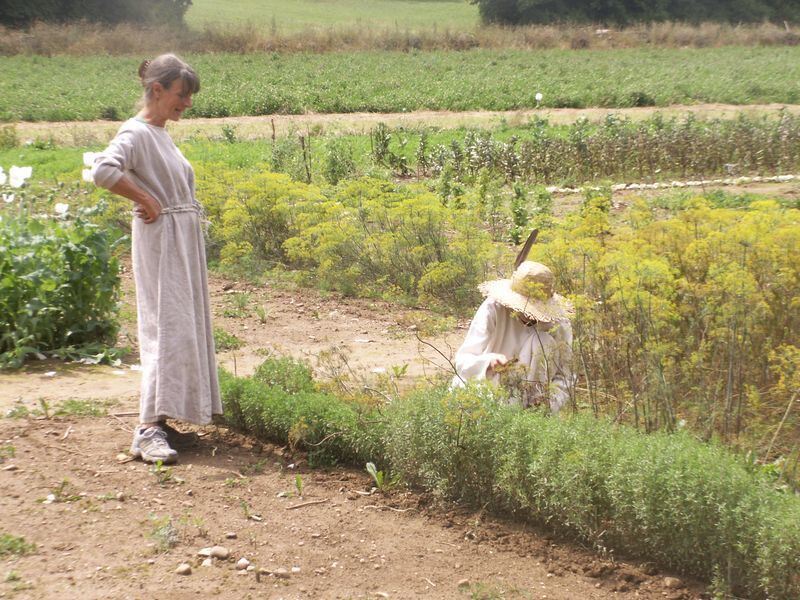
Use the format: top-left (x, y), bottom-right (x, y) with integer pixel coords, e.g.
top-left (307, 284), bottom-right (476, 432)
top-left (470, 0), bottom-right (800, 25)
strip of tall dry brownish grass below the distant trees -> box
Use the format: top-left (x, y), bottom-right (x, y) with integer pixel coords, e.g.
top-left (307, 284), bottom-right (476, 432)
top-left (0, 20), bottom-right (800, 56)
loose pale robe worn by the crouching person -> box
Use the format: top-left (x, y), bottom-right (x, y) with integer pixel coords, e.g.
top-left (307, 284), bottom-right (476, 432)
top-left (452, 298), bottom-right (574, 413)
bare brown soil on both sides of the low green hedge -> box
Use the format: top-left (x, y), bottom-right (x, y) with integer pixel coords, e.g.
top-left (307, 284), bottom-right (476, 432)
top-left (0, 276), bottom-right (703, 600)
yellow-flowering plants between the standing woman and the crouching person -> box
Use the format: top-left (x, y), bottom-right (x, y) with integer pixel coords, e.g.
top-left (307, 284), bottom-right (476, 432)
top-left (198, 168), bottom-right (496, 311)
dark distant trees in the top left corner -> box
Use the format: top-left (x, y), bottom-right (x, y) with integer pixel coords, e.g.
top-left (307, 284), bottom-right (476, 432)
top-left (0, 0), bottom-right (192, 27)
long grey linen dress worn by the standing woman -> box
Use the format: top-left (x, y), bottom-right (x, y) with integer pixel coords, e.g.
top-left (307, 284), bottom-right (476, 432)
top-left (92, 118), bottom-right (222, 425)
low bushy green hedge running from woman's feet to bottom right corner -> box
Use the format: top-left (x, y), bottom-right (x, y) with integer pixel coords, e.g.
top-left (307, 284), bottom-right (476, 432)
top-left (221, 359), bottom-right (800, 600)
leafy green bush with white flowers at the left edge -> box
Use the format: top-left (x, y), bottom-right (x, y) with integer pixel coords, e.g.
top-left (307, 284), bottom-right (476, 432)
top-left (0, 203), bottom-right (119, 367)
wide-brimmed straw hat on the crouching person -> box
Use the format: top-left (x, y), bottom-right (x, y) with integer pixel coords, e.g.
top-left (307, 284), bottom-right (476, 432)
top-left (478, 260), bottom-right (574, 323)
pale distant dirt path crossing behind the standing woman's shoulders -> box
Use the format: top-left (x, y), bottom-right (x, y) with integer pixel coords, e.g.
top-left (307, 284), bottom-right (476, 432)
top-left (16, 104), bottom-right (800, 146)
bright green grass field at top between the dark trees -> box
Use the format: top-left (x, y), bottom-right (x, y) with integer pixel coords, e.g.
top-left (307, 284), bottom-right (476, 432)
top-left (186, 0), bottom-right (479, 32)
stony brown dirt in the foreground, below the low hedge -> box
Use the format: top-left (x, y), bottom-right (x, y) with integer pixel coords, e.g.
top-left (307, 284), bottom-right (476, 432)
top-left (0, 417), bottom-right (699, 600)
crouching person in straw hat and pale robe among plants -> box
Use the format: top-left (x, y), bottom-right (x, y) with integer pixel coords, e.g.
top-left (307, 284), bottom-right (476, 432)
top-left (453, 261), bottom-right (573, 413)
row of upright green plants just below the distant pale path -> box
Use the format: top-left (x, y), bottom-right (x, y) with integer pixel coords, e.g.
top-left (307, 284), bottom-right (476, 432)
top-left (9, 110), bottom-right (800, 190)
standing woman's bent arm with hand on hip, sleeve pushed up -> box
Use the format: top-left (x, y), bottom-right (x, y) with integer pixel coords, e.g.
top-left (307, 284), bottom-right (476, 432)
top-left (92, 131), bottom-right (161, 223)
